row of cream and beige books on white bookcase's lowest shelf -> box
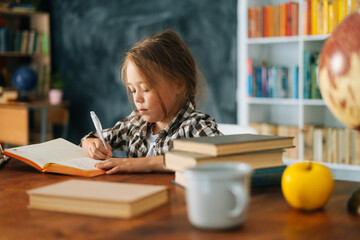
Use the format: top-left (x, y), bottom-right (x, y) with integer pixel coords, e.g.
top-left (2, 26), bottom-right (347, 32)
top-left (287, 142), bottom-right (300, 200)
top-left (250, 123), bottom-right (360, 165)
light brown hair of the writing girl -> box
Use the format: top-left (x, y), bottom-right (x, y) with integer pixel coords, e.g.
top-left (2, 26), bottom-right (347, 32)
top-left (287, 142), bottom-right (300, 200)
top-left (121, 29), bottom-right (206, 116)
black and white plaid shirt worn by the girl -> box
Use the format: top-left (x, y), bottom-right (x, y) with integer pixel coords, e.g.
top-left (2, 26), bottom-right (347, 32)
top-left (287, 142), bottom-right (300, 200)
top-left (82, 102), bottom-right (222, 157)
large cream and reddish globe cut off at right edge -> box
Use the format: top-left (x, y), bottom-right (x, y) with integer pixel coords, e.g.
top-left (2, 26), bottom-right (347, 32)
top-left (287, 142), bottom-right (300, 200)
top-left (319, 9), bottom-right (360, 131)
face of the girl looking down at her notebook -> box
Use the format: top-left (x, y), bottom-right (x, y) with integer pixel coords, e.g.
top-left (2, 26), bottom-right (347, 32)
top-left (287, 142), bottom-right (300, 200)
top-left (126, 62), bottom-right (183, 133)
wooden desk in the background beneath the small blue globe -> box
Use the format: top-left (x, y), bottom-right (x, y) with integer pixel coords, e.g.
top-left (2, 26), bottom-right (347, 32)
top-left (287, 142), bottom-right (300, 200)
top-left (0, 101), bottom-right (69, 145)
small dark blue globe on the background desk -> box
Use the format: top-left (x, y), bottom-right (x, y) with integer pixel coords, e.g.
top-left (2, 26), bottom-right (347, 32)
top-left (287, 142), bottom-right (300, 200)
top-left (12, 67), bottom-right (37, 93)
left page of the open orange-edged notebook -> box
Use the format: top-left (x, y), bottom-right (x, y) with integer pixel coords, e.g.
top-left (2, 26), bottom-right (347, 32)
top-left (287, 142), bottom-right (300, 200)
top-left (6, 138), bottom-right (88, 168)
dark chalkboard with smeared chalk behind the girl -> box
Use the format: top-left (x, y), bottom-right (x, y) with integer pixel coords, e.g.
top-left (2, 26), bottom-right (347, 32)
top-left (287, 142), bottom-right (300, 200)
top-left (50, 0), bottom-right (237, 143)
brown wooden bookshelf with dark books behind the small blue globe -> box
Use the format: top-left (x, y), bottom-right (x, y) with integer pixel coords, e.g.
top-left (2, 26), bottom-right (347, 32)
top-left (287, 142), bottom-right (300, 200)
top-left (0, 9), bottom-right (51, 100)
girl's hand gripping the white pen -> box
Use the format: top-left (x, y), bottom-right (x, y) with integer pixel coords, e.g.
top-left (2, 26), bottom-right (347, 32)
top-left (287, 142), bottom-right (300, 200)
top-left (81, 138), bottom-right (112, 160)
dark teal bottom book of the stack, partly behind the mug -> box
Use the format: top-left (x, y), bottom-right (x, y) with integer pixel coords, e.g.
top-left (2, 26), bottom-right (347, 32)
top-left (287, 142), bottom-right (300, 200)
top-left (173, 165), bottom-right (286, 188)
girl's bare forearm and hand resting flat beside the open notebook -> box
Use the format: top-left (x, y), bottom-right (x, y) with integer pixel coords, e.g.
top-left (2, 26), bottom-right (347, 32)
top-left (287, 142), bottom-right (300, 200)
top-left (95, 155), bottom-right (169, 174)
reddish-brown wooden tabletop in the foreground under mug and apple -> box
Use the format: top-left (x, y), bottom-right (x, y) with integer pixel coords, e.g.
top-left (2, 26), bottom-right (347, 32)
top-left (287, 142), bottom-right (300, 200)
top-left (0, 159), bottom-right (360, 240)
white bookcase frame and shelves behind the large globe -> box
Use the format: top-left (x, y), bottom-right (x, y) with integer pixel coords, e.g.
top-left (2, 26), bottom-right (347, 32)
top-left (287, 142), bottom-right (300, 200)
top-left (237, 0), bottom-right (360, 180)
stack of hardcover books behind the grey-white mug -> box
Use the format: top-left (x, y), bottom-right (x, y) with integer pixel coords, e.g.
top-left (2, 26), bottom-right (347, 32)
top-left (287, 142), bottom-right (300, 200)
top-left (164, 134), bottom-right (294, 187)
